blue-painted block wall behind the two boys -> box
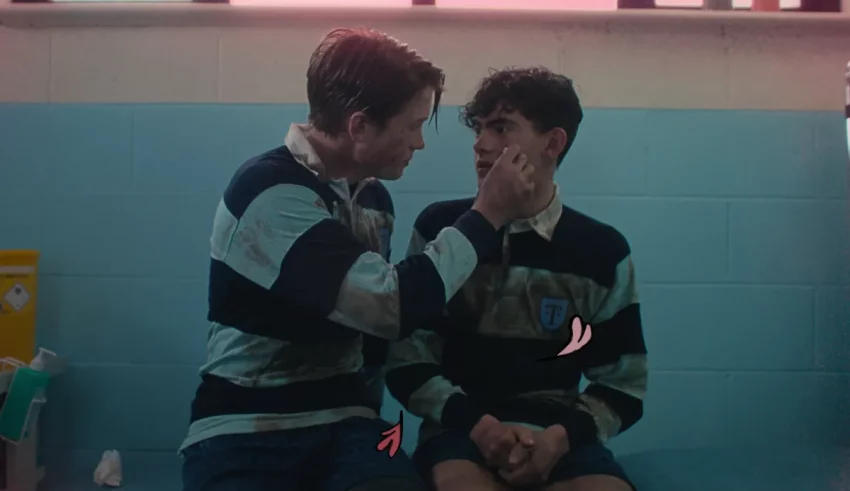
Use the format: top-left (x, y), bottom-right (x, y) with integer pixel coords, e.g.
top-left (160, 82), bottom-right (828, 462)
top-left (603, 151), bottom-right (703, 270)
top-left (0, 105), bottom-right (850, 462)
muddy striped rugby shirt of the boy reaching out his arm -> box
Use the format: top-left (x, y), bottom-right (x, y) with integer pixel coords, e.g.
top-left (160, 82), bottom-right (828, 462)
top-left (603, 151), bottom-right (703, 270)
top-left (183, 125), bottom-right (496, 447)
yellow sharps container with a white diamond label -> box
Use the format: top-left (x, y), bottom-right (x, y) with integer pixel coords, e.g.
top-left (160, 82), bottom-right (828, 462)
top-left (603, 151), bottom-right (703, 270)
top-left (0, 250), bottom-right (40, 364)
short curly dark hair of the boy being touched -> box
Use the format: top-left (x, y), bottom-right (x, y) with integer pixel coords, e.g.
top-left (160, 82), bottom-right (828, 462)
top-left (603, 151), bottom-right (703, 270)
top-left (460, 67), bottom-right (584, 166)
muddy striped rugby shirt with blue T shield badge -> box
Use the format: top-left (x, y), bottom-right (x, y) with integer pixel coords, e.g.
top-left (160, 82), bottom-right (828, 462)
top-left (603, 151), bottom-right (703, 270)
top-left (386, 188), bottom-right (647, 448)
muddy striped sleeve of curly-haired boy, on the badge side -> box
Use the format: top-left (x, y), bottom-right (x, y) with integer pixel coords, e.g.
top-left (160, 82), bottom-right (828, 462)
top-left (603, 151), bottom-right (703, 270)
top-left (563, 255), bottom-right (648, 448)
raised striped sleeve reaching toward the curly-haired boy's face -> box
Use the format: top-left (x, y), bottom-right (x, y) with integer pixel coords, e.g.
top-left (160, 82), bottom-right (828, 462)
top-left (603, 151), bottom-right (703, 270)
top-left (219, 184), bottom-right (496, 339)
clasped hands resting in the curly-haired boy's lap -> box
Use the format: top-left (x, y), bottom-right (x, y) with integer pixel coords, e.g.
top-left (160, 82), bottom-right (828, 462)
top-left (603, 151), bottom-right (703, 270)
top-left (469, 415), bottom-right (569, 487)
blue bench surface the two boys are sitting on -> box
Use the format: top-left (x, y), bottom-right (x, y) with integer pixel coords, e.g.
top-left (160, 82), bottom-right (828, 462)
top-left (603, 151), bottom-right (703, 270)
top-left (36, 447), bottom-right (850, 491)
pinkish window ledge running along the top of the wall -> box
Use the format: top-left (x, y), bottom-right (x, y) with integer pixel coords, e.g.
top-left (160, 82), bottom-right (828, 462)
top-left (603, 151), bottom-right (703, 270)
top-left (0, 0), bottom-right (850, 32)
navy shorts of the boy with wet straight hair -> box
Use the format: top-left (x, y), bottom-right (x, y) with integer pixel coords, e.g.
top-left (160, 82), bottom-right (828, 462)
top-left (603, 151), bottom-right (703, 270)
top-left (182, 418), bottom-right (424, 491)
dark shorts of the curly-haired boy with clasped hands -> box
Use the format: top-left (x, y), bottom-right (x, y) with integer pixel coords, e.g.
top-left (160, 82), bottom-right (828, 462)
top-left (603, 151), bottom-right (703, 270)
top-left (413, 431), bottom-right (634, 489)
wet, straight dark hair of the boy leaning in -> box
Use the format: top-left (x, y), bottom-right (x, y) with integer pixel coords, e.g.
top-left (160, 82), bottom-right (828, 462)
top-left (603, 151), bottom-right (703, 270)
top-left (307, 28), bottom-right (445, 135)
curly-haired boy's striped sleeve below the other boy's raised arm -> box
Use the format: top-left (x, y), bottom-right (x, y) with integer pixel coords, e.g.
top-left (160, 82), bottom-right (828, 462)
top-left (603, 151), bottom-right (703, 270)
top-left (386, 228), bottom-right (484, 431)
